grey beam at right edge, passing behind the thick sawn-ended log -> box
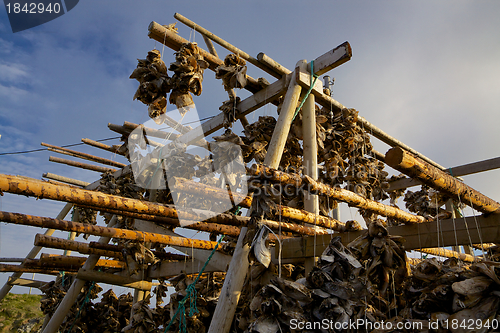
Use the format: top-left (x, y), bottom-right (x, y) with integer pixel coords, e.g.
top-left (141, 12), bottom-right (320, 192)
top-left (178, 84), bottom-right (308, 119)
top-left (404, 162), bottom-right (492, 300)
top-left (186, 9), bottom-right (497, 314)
top-left (388, 157), bottom-right (500, 191)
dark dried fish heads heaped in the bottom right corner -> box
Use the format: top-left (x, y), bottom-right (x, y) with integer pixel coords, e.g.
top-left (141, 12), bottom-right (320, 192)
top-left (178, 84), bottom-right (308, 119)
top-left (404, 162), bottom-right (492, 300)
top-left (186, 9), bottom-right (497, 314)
top-left (400, 258), bottom-right (500, 333)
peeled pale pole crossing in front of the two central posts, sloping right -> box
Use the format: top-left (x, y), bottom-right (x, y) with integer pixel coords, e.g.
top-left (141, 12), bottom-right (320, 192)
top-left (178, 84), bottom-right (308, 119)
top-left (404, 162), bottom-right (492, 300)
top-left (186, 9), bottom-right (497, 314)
top-left (248, 164), bottom-right (426, 223)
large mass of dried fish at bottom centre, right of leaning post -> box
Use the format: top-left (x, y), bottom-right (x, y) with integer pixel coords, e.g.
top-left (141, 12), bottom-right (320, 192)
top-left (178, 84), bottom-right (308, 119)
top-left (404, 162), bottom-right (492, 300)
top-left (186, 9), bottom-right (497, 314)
top-left (230, 221), bottom-right (409, 333)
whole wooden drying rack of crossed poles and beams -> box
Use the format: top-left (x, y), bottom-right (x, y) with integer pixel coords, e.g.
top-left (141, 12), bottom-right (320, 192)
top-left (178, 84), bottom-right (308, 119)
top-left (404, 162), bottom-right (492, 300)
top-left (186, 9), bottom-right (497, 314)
top-left (0, 14), bottom-right (500, 333)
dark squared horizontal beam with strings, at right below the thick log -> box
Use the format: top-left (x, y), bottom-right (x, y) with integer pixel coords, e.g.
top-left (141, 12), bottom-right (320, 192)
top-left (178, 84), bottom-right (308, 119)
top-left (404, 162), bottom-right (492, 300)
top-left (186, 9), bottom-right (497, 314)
top-left (282, 215), bottom-right (500, 259)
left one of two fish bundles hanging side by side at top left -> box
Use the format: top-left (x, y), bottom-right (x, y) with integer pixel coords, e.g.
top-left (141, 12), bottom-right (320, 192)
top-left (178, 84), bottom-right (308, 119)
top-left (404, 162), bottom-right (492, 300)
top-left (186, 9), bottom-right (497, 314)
top-left (130, 50), bottom-right (171, 118)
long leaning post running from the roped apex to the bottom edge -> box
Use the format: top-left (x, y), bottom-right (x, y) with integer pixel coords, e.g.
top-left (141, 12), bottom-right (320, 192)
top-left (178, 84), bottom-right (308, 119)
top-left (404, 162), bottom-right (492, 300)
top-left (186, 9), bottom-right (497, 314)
top-left (208, 60), bottom-right (305, 333)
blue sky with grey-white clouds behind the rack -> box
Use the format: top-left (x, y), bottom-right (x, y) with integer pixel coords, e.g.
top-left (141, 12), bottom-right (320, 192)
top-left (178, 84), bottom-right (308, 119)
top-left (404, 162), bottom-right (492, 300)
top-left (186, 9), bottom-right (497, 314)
top-left (0, 0), bottom-right (500, 292)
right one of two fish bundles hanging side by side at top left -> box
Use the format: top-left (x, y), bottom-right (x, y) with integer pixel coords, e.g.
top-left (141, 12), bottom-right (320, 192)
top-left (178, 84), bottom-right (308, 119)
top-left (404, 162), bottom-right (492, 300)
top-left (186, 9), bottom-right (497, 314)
top-left (169, 43), bottom-right (208, 115)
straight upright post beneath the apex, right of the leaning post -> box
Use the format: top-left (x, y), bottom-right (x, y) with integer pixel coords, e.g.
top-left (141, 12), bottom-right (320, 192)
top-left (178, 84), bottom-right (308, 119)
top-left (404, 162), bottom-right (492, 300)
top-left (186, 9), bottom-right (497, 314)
top-left (301, 64), bottom-right (319, 274)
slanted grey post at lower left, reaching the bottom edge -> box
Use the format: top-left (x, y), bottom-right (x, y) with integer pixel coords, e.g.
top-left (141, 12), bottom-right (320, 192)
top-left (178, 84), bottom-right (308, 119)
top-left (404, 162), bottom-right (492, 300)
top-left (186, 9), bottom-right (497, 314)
top-left (42, 215), bottom-right (116, 333)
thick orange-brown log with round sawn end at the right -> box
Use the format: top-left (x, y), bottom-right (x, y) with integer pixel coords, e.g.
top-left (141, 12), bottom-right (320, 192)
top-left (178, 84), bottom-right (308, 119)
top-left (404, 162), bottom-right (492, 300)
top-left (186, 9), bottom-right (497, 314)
top-left (385, 148), bottom-right (500, 213)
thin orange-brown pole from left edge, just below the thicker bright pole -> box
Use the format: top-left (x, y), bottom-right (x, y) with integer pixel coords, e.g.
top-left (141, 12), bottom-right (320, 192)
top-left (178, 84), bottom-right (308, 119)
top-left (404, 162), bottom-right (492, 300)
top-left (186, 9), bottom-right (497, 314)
top-left (0, 212), bottom-right (217, 250)
